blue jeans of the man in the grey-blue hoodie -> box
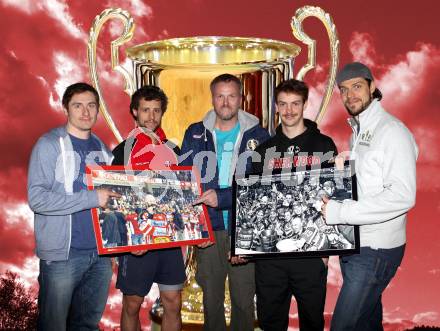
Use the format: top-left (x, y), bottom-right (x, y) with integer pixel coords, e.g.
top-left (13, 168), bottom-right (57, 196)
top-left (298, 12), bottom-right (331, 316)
top-left (38, 250), bottom-right (112, 331)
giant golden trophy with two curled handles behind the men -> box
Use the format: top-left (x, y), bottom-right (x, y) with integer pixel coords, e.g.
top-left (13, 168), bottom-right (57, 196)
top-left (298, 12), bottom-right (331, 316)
top-left (87, 6), bottom-right (339, 330)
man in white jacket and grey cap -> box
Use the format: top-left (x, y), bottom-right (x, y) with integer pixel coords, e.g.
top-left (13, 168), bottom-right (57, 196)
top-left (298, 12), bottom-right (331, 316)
top-left (322, 62), bottom-right (418, 330)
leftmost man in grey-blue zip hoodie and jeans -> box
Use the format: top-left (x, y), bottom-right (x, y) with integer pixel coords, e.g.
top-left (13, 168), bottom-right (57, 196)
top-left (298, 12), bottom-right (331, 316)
top-left (28, 83), bottom-right (119, 331)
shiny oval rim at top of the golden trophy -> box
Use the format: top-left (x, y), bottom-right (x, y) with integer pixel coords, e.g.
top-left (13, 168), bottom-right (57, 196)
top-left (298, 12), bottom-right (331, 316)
top-left (126, 36), bottom-right (301, 68)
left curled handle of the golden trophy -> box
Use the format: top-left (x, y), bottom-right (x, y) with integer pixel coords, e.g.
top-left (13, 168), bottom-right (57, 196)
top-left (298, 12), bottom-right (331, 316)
top-left (87, 8), bottom-right (134, 142)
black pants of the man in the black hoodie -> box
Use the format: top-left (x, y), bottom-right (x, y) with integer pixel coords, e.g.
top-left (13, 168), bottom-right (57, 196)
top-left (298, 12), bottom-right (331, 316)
top-left (255, 258), bottom-right (327, 331)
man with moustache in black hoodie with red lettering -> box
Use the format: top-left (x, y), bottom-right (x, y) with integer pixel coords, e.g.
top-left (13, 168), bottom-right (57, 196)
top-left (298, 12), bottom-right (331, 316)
top-left (252, 79), bottom-right (337, 331)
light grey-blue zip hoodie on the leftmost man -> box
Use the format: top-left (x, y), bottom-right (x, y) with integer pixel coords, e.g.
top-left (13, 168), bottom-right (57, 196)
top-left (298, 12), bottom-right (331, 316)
top-left (27, 127), bottom-right (112, 261)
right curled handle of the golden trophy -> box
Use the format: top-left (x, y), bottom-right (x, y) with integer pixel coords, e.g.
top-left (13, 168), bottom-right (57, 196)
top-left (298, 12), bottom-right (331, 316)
top-left (291, 6), bottom-right (339, 123)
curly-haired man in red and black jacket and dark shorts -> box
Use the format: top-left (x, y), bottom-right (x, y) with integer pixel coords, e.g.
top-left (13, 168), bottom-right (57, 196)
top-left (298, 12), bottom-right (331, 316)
top-left (112, 86), bottom-right (186, 331)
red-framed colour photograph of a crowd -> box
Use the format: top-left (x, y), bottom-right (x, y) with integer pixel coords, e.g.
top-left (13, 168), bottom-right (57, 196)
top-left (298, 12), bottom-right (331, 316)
top-left (86, 166), bottom-right (215, 254)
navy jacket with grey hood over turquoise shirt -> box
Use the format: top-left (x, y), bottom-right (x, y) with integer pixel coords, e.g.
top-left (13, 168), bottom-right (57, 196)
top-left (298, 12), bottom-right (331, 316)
top-left (179, 110), bottom-right (270, 231)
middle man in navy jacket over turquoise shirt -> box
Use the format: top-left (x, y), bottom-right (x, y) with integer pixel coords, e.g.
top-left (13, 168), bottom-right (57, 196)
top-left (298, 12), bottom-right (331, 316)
top-left (181, 74), bottom-right (269, 331)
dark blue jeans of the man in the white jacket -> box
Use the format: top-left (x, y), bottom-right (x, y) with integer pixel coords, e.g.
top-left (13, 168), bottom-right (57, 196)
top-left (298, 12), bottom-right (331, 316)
top-left (330, 245), bottom-right (405, 331)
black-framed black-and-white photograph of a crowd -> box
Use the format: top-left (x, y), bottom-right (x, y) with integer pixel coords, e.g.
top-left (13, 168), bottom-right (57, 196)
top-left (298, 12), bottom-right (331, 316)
top-left (231, 162), bottom-right (359, 259)
